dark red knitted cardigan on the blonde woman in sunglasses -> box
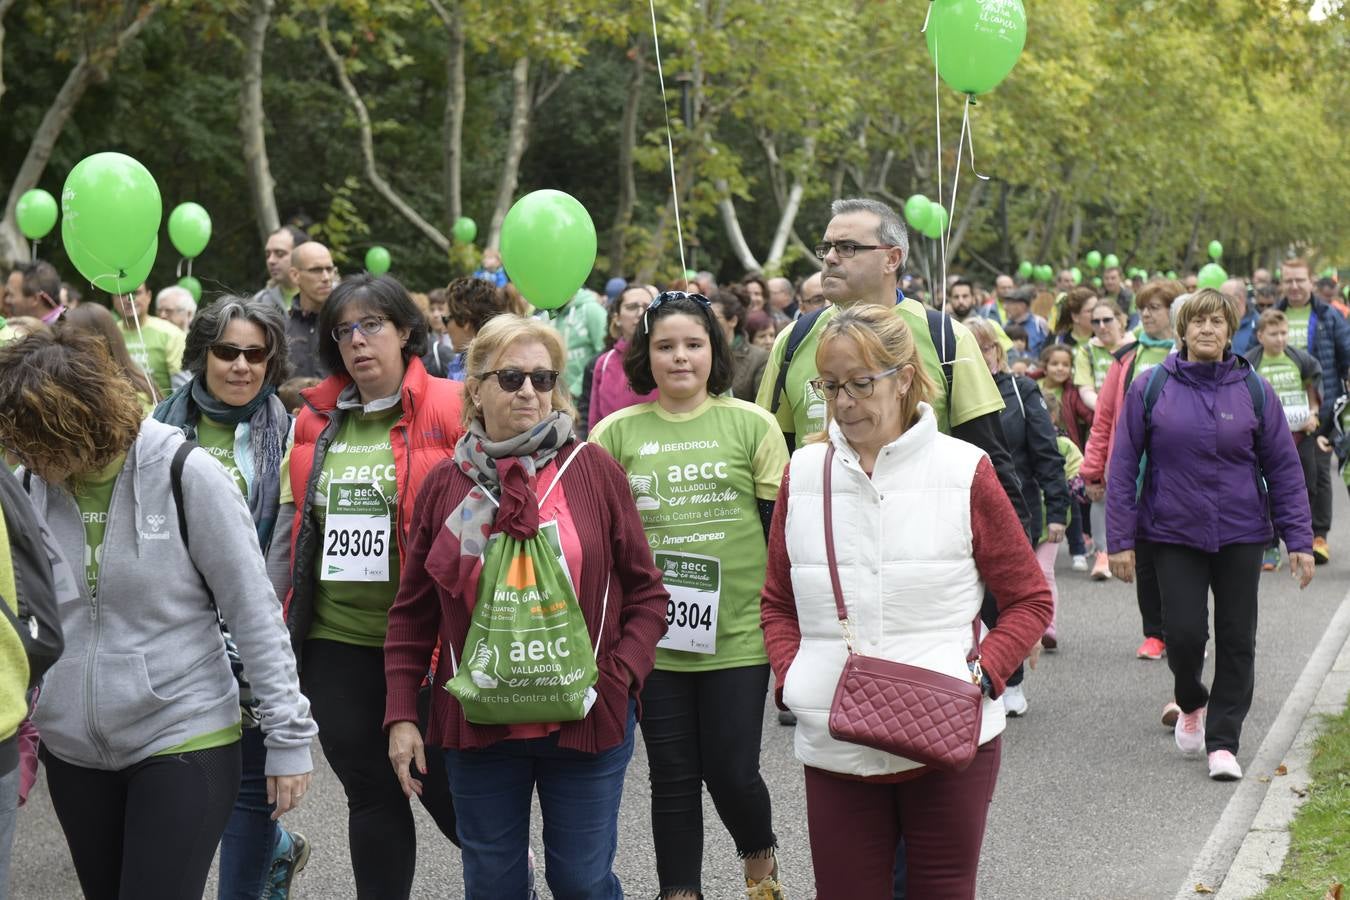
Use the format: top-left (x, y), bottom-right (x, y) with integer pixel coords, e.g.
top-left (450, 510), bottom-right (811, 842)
top-left (385, 444), bottom-right (670, 753)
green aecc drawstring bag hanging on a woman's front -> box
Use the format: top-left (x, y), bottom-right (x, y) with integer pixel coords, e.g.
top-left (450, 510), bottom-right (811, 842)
top-left (446, 522), bottom-right (609, 725)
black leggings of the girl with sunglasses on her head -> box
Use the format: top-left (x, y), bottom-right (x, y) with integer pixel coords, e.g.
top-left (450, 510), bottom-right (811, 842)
top-left (643, 665), bottom-right (778, 893)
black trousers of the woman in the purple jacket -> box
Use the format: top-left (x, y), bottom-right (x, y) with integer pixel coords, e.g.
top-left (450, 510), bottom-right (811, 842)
top-left (1152, 544), bottom-right (1265, 753)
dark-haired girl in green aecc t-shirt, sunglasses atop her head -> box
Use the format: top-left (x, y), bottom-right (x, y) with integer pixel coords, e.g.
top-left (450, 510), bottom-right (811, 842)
top-left (591, 291), bottom-right (787, 900)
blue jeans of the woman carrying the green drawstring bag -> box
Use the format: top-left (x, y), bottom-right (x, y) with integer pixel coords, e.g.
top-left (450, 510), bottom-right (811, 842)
top-left (446, 702), bottom-right (637, 900)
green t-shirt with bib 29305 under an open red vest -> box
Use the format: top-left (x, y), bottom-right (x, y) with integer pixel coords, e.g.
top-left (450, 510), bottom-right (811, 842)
top-left (309, 405), bottom-right (402, 646)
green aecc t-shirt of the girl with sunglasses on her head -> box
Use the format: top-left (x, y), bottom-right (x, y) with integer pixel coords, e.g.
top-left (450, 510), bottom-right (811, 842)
top-left (591, 397), bottom-right (787, 672)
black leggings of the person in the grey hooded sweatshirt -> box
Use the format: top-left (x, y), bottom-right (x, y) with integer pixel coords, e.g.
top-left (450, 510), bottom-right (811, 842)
top-left (39, 741), bottom-right (240, 900)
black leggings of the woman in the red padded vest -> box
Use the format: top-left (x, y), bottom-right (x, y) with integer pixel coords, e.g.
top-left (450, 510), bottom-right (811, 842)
top-left (300, 640), bottom-right (458, 900)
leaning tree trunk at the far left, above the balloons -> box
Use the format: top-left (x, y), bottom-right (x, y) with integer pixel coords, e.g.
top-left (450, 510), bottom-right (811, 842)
top-left (0, 3), bottom-right (159, 263)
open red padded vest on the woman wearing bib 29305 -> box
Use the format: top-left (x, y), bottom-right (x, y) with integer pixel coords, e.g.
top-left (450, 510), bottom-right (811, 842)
top-left (284, 356), bottom-right (464, 644)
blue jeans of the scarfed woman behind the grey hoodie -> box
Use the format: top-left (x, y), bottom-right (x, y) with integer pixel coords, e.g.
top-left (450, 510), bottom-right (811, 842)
top-left (216, 727), bottom-right (279, 900)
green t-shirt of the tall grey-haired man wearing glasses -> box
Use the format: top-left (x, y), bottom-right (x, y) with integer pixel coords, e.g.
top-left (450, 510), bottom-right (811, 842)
top-left (755, 297), bottom-right (1003, 445)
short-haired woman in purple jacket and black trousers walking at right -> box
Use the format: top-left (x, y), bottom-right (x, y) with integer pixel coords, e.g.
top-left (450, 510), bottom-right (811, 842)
top-left (1107, 289), bottom-right (1314, 781)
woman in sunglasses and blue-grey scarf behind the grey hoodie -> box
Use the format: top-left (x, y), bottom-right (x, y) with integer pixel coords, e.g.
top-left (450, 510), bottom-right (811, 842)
top-left (153, 297), bottom-right (309, 900)
